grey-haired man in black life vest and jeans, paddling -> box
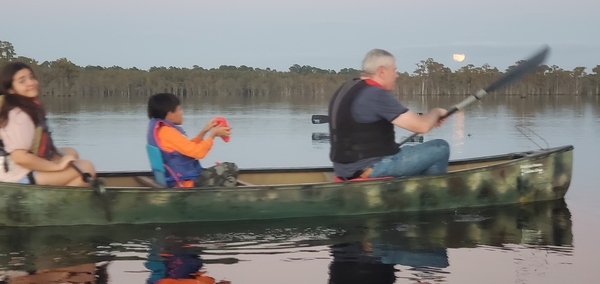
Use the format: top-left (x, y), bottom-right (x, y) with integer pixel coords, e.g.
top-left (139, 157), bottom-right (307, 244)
top-left (329, 49), bottom-right (450, 180)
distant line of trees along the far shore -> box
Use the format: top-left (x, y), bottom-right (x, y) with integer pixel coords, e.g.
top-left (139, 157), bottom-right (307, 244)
top-left (0, 41), bottom-right (600, 97)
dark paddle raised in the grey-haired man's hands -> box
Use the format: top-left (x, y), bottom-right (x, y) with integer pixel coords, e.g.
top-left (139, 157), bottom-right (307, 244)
top-left (398, 46), bottom-right (550, 146)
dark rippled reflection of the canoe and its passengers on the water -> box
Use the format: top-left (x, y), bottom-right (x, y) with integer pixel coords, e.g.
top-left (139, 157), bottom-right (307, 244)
top-left (0, 200), bottom-right (573, 283)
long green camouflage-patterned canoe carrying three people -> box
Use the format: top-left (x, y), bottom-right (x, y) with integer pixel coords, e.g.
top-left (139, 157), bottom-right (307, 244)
top-left (0, 145), bottom-right (573, 226)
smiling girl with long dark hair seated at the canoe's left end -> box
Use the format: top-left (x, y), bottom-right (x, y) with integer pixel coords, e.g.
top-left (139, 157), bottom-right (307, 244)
top-left (0, 61), bottom-right (96, 186)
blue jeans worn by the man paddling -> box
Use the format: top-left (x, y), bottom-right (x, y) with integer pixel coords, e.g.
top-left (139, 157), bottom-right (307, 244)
top-left (369, 139), bottom-right (450, 178)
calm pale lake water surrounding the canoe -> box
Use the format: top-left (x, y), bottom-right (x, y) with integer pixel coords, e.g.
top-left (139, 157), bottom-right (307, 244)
top-left (0, 95), bottom-right (600, 283)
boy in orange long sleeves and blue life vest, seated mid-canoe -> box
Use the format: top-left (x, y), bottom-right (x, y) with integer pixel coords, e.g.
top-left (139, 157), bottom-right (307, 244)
top-left (147, 93), bottom-right (238, 187)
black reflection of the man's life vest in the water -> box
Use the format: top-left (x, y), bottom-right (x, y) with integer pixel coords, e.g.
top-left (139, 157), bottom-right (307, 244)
top-left (328, 242), bottom-right (396, 284)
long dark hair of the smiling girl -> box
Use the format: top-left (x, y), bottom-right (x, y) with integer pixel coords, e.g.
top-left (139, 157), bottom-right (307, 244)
top-left (0, 61), bottom-right (45, 127)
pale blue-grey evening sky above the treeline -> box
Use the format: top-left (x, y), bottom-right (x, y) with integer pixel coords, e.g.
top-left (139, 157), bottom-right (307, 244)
top-left (0, 0), bottom-right (600, 73)
